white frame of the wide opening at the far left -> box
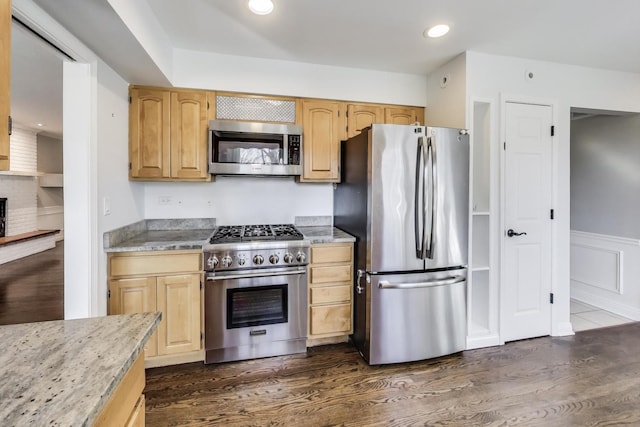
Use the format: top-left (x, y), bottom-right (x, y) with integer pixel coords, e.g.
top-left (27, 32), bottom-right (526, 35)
top-left (12, 0), bottom-right (102, 319)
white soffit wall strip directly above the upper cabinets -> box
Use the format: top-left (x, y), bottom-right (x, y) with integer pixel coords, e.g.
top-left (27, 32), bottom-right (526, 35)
top-left (172, 49), bottom-right (427, 106)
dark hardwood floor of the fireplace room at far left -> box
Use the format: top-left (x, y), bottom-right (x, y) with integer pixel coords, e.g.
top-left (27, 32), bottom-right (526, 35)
top-left (0, 242), bottom-right (64, 325)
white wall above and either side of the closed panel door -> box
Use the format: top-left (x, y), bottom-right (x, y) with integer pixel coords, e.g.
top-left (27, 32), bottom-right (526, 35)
top-left (467, 52), bottom-right (640, 335)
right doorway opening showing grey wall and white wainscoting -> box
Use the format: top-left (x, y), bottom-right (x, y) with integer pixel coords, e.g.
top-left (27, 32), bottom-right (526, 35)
top-left (570, 108), bottom-right (640, 331)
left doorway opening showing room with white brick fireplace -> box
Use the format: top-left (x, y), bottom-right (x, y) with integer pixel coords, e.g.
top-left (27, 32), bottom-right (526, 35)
top-left (0, 18), bottom-right (68, 324)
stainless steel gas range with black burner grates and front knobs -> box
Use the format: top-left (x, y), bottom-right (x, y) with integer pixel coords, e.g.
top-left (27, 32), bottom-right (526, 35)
top-left (203, 224), bottom-right (309, 363)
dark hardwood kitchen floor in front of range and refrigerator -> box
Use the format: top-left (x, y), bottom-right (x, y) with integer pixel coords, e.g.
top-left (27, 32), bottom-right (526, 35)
top-left (145, 323), bottom-right (640, 426)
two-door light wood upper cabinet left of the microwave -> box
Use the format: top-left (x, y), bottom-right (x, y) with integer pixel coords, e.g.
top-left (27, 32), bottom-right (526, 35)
top-left (129, 87), bottom-right (211, 181)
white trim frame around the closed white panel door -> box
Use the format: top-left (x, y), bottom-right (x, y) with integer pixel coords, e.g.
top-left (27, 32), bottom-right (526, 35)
top-left (498, 93), bottom-right (569, 344)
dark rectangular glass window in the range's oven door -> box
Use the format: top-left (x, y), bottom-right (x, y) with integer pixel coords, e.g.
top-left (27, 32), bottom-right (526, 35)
top-left (227, 284), bottom-right (289, 329)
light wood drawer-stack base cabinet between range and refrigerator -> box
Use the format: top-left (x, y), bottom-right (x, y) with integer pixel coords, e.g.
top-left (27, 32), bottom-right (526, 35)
top-left (307, 243), bottom-right (353, 346)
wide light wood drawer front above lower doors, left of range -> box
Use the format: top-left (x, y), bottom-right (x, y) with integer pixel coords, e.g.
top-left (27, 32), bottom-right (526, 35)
top-left (109, 252), bottom-right (202, 277)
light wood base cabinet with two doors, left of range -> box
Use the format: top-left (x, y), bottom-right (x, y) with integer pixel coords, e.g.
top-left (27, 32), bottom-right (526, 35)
top-left (108, 250), bottom-right (204, 367)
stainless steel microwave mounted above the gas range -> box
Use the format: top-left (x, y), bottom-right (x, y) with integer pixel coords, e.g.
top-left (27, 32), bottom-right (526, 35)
top-left (209, 120), bottom-right (302, 176)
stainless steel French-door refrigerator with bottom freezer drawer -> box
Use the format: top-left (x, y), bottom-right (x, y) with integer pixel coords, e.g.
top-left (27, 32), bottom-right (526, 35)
top-left (334, 124), bottom-right (469, 365)
